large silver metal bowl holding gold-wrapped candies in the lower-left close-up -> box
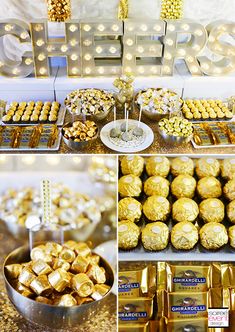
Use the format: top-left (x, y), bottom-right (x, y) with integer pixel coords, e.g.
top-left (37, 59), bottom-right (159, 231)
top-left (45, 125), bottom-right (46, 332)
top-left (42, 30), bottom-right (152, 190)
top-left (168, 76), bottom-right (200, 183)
top-left (3, 246), bottom-right (114, 329)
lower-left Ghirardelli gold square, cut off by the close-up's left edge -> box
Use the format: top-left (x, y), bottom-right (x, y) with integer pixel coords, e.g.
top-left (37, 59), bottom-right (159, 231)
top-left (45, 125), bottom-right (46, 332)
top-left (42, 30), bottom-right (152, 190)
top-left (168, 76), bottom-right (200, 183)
top-left (118, 297), bottom-right (153, 324)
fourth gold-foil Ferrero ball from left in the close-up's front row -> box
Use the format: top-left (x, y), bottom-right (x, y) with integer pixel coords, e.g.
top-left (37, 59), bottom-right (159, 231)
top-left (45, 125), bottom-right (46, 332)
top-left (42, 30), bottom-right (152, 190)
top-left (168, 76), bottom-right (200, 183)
top-left (200, 222), bottom-right (228, 250)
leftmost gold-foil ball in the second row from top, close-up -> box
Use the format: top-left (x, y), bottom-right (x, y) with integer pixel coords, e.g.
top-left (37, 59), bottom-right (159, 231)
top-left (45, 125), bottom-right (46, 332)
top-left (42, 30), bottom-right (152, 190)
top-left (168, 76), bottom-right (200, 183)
top-left (118, 174), bottom-right (142, 197)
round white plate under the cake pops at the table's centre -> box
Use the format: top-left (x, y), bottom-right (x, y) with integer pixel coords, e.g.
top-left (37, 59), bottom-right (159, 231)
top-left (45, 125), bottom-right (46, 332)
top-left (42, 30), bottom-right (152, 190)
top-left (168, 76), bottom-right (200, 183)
top-left (100, 120), bottom-right (154, 153)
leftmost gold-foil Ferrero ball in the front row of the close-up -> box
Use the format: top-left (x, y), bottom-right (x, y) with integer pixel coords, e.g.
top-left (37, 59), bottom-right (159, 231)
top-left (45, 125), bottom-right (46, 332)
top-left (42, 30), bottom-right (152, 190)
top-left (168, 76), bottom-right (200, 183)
top-left (118, 220), bottom-right (140, 250)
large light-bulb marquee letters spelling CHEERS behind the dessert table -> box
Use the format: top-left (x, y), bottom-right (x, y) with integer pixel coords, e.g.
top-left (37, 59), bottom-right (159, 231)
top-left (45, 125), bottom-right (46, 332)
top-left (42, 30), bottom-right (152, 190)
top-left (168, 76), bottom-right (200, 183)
top-left (0, 20), bottom-right (235, 78)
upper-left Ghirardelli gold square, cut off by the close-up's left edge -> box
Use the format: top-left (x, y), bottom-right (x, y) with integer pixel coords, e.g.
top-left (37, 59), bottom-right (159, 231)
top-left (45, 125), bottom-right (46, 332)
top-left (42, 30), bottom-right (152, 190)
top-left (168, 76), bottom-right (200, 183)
top-left (118, 265), bottom-right (156, 298)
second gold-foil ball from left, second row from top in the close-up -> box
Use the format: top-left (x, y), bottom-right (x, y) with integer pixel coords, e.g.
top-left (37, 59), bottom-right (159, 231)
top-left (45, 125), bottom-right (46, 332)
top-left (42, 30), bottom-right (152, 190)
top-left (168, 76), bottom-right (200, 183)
top-left (144, 175), bottom-right (170, 197)
